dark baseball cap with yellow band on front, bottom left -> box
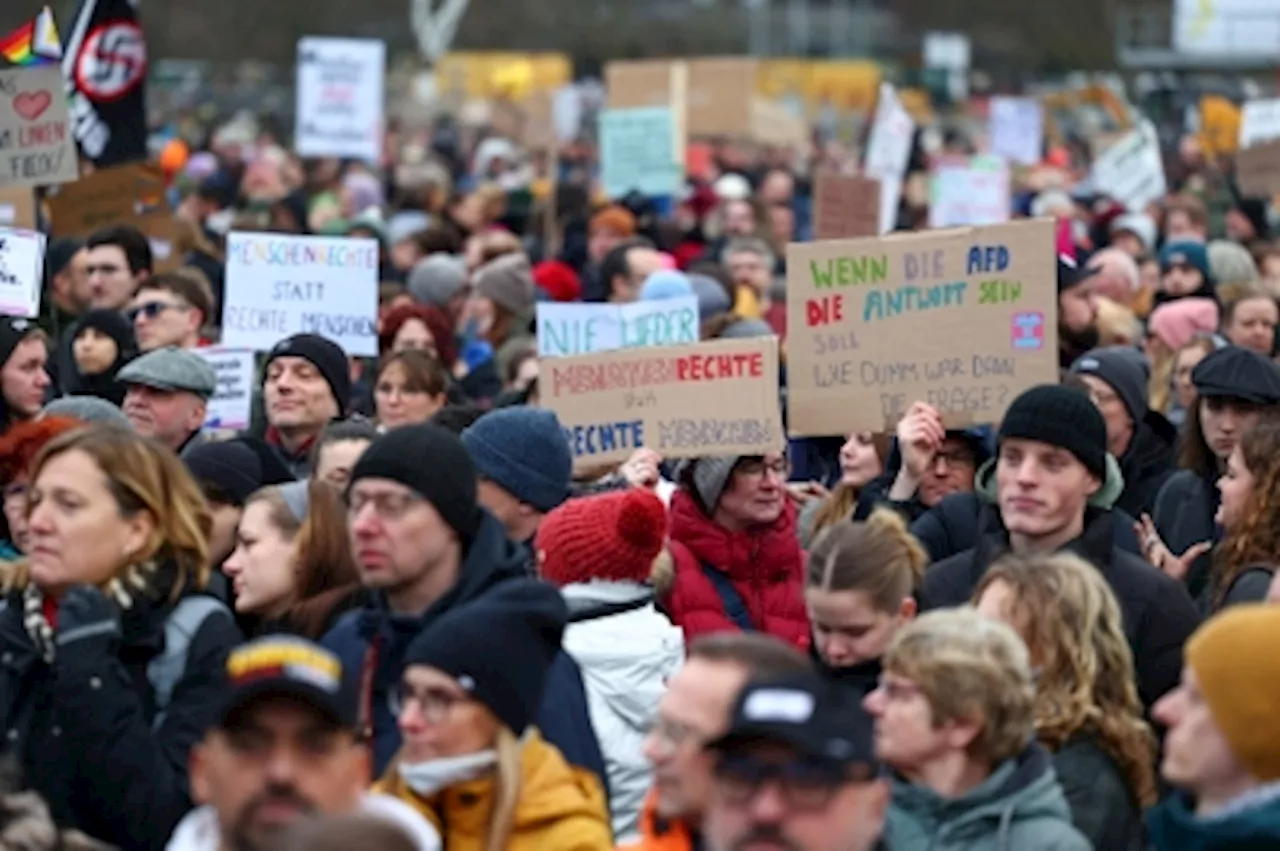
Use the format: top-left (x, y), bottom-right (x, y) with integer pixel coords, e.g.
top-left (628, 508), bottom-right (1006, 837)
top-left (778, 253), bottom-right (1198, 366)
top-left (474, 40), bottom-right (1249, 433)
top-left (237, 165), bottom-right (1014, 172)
top-left (219, 635), bottom-right (358, 729)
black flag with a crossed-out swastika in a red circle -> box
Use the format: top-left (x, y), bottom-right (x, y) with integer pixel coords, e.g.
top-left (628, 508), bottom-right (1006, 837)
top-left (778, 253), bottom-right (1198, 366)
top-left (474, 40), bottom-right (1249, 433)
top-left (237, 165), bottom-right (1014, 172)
top-left (63, 0), bottom-right (147, 168)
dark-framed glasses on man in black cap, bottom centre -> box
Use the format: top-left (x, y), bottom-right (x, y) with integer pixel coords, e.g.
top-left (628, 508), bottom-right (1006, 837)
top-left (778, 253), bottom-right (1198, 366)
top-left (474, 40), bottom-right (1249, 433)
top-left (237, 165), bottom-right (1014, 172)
top-left (716, 754), bottom-right (874, 811)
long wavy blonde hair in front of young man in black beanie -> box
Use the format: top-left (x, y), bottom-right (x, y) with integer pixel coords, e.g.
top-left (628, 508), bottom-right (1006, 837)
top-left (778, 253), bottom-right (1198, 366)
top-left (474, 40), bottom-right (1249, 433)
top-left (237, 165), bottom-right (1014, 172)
top-left (974, 553), bottom-right (1156, 806)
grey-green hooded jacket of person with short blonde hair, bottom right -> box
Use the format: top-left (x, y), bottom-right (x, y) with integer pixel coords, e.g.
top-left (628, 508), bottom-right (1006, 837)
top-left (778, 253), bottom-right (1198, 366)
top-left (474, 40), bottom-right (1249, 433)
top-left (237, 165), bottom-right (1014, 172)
top-left (884, 745), bottom-right (1090, 851)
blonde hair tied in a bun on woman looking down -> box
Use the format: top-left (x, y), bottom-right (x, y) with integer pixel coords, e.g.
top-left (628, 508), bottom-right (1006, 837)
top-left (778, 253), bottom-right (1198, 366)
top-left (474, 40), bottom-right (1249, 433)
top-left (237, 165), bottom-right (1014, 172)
top-left (805, 508), bottom-right (929, 614)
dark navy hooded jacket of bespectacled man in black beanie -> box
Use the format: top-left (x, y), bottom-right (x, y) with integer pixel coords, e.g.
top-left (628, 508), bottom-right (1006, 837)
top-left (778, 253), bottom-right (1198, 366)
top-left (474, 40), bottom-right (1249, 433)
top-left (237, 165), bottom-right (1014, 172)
top-left (321, 512), bottom-right (605, 783)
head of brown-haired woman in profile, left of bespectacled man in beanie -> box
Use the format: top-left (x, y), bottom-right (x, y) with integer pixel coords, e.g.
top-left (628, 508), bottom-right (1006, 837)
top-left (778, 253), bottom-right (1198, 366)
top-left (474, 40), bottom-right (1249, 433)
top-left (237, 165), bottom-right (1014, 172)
top-left (223, 479), bottom-right (361, 641)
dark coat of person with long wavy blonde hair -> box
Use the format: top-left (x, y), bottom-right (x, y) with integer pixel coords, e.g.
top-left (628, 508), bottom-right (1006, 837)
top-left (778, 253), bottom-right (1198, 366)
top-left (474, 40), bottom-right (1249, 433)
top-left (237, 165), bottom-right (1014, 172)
top-left (1053, 733), bottom-right (1144, 851)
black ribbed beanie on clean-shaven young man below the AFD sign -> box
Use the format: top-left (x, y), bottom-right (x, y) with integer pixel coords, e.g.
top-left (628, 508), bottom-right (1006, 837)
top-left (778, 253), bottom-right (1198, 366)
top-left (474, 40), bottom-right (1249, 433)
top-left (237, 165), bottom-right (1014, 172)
top-left (996, 384), bottom-right (1107, 481)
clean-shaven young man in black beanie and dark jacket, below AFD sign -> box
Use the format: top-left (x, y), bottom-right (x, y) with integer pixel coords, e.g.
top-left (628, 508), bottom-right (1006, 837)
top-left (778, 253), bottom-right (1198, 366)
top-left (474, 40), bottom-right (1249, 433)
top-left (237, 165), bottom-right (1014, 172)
top-left (922, 384), bottom-right (1199, 706)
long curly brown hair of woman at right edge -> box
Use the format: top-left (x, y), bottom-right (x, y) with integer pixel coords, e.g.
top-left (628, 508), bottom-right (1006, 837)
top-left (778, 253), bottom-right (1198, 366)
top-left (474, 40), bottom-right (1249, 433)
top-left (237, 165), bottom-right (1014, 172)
top-left (1212, 413), bottom-right (1280, 609)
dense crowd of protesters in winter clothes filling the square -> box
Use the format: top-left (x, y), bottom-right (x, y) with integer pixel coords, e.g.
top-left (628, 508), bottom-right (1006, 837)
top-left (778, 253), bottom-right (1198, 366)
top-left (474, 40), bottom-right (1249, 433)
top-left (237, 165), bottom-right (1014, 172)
top-left (0, 84), bottom-right (1280, 851)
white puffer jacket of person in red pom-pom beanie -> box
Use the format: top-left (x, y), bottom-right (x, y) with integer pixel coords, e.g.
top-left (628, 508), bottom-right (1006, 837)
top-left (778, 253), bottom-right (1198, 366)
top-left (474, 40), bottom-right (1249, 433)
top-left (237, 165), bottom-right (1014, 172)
top-left (561, 582), bottom-right (685, 843)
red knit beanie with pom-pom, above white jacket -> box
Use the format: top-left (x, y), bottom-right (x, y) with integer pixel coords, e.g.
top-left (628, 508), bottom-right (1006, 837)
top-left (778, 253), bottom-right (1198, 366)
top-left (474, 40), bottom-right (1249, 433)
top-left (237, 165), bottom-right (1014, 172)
top-left (536, 488), bottom-right (667, 586)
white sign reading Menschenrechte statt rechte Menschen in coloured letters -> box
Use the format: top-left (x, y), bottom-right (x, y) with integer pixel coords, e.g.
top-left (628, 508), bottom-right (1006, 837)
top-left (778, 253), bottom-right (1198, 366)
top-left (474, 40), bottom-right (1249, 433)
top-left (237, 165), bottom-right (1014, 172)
top-left (221, 233), bottom-right (378, 357)
